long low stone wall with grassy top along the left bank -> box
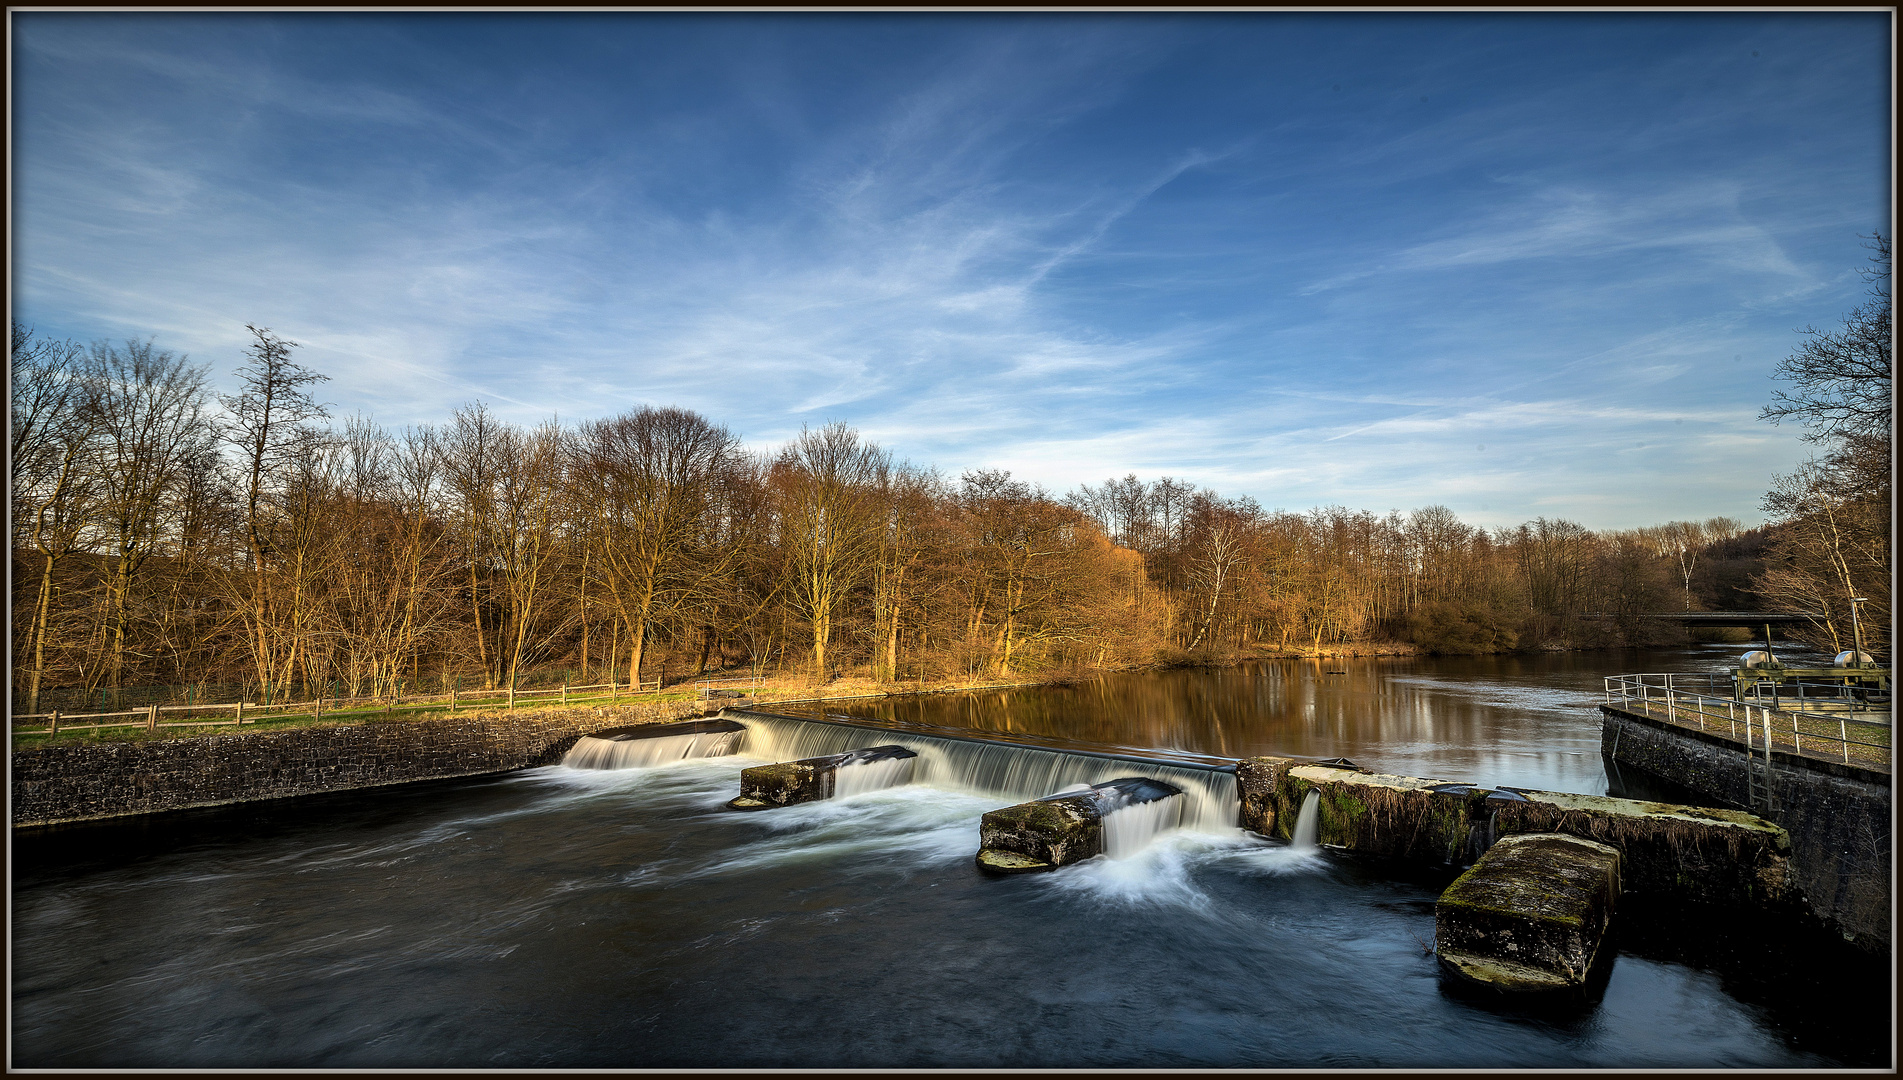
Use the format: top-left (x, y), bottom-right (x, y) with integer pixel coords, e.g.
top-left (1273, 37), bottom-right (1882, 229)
top-left (11, 702), bottom-right (702, 827)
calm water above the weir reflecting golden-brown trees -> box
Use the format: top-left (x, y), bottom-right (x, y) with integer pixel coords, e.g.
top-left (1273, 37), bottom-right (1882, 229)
top-left (841, 645), bottom-right (1804, 795)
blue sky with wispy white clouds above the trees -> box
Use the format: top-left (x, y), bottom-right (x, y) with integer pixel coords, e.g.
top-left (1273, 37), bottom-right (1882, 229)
top-left (11, 11), bottom-right (1892, 529)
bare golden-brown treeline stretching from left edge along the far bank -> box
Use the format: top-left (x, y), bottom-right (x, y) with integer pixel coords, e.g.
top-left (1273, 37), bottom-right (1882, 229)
top-left (11, 311), bottom-right (1880, 711)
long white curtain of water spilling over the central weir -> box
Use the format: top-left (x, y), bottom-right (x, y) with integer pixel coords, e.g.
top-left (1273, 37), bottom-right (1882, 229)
top-left (725, 709), bottom-right (1239, 832)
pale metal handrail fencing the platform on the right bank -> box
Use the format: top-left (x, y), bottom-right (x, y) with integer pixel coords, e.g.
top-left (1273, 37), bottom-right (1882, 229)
top-left (1606, 673), bottom-right (1893, 772)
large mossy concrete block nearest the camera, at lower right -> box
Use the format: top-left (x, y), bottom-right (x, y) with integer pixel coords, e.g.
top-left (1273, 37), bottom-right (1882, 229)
top-left (1435, 833), bottom-right (1619, 991)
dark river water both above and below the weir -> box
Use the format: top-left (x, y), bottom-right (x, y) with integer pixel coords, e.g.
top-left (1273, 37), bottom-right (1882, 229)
top-left (11, 646), bottom-right (1888, 1069)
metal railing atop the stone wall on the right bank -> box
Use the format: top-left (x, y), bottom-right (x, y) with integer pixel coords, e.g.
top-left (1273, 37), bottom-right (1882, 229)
top-left (1606, 673), bottom-right (1892, 772)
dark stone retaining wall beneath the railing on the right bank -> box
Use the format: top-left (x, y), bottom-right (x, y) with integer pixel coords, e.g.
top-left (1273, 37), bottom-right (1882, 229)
top-left (1600, 705), bottom-right (1892, 951)
